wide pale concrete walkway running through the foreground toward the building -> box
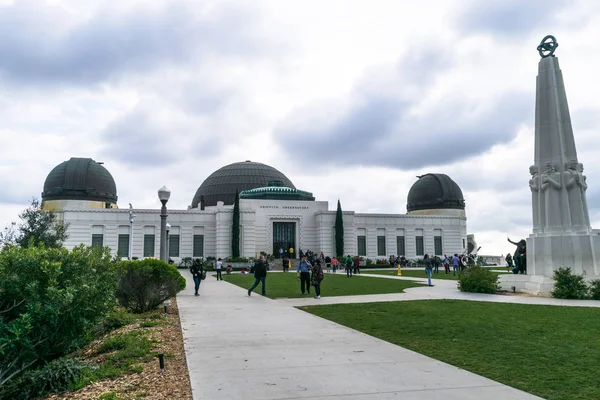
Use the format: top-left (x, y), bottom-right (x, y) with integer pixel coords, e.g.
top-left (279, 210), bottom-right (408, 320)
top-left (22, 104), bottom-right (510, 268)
top-left (177, 272), bottom-right (538, 400)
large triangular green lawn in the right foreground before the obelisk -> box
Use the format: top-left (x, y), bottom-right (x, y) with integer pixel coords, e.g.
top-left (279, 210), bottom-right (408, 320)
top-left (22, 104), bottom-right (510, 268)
top-left (300, 300), bottom-right (600, 400)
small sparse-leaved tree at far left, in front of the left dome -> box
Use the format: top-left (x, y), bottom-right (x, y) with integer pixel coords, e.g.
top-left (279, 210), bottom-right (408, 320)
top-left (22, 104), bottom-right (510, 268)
top-left (8, 198), bottom-right (69, 248)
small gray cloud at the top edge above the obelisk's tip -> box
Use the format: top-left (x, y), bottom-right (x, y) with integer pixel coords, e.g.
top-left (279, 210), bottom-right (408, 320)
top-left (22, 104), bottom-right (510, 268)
top-left (457, 0), bottom-right (568, 39)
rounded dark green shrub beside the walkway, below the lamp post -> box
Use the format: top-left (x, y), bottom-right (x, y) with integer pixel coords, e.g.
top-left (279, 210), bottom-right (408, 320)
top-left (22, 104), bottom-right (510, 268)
top-left (117, 258), bottom-right (185, 313)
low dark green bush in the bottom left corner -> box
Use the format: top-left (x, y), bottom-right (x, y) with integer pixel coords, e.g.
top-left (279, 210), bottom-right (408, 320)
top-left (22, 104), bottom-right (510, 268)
top-left (0, 357), bottom-right (98, 400)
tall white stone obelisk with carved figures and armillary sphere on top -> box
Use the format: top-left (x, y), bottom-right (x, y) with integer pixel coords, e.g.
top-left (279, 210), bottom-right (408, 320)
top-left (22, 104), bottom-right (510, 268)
top-left (501, 36), bottom-right (600, 296)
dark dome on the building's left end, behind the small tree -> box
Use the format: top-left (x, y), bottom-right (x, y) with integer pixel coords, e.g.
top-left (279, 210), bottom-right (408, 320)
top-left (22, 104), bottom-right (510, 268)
top-left (42, 158), bottom-right (117, 204)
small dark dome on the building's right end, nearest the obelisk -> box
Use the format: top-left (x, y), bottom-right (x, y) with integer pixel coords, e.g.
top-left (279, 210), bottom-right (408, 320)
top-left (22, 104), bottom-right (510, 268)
top-left (406, 174), bottom-right (465, 212)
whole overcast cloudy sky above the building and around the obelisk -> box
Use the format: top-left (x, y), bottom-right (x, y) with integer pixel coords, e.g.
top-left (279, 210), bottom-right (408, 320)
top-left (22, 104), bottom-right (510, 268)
top-left (0, 0), bottom-right (600, 254)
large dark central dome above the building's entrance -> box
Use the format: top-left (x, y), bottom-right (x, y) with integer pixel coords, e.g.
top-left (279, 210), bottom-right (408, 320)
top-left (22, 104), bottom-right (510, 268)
top-left (192, 161), bottom-right (296, 208)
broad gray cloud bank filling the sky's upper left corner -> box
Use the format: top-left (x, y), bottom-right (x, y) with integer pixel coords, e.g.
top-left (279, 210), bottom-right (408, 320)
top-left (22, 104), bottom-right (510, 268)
top-left (0, 2), bottom-right (264, 85)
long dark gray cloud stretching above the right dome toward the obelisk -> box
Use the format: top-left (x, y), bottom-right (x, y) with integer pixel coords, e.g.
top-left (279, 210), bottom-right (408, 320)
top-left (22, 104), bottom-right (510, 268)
top-left (276, 79), bottom-right (531, 169)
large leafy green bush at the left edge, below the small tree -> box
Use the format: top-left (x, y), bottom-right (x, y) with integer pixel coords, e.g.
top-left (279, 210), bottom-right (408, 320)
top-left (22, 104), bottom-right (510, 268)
top-left (0, 245), bottom-right (116, 386)
